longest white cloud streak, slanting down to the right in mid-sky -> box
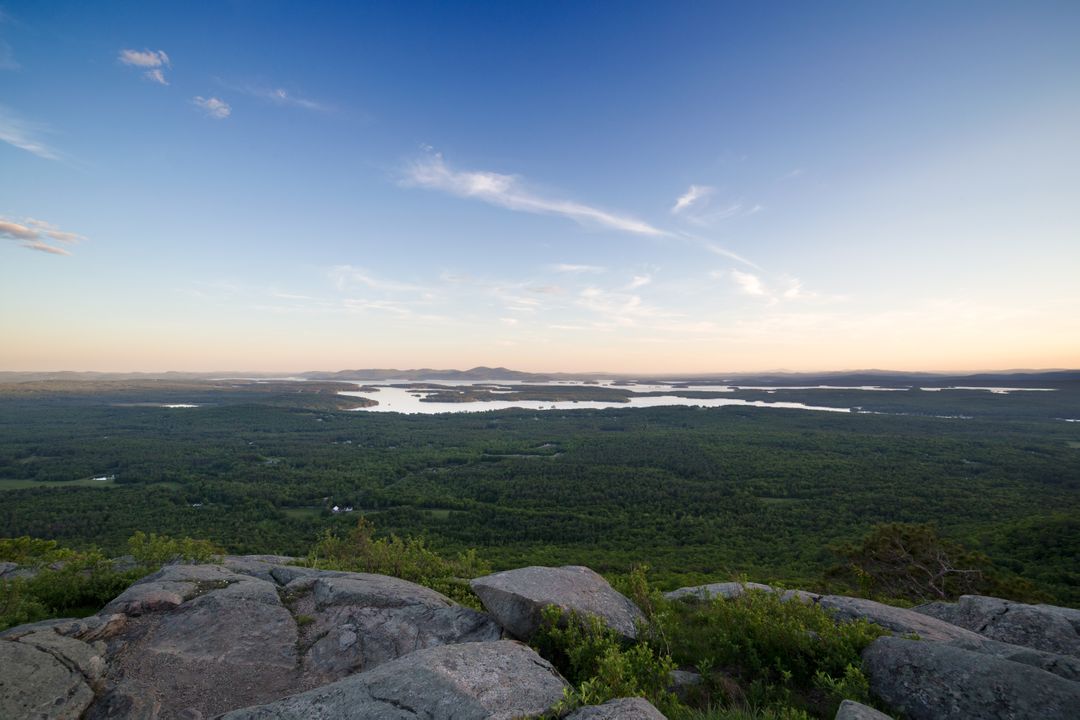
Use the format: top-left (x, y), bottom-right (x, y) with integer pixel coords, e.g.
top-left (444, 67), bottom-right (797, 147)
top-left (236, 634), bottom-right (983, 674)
top-left (403, 153), bottom-right (671, 236)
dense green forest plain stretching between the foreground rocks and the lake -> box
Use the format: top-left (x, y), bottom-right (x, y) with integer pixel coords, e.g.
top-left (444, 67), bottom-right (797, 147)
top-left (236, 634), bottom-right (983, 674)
top-left (0, 380), bottom-right (1080, 606)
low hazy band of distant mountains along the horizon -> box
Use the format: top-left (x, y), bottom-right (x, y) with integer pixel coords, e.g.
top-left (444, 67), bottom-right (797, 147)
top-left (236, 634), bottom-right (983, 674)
top-left (0, 366), bottom-right (1080, 388)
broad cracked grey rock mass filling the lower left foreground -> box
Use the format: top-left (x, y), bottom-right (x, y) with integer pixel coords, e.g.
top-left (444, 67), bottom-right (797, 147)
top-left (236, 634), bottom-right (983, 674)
top-left (0, 556), bottom-right (514, 720)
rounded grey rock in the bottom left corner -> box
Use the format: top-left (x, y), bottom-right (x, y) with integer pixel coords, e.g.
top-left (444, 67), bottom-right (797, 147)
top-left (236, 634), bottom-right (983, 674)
top-left (0, 640), bottom-right (94, 720)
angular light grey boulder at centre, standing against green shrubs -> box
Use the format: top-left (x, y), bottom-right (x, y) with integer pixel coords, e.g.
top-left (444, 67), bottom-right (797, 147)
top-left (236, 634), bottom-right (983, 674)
top-left (471, 566), bottom-right (645, 640)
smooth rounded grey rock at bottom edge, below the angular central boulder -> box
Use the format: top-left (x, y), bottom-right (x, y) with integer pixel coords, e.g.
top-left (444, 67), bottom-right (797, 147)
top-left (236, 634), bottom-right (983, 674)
top-left (221, 640), bottom-right (568, 720)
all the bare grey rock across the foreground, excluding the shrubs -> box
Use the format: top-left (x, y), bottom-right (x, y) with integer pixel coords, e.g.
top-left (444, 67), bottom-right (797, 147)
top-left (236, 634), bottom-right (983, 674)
top-left (0, 556), bottom-right (1080, 720)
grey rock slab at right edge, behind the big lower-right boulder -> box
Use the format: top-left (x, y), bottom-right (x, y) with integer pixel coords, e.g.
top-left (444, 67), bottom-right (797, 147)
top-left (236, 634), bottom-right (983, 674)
top-left (915, 595), bottom-right (1080, 657)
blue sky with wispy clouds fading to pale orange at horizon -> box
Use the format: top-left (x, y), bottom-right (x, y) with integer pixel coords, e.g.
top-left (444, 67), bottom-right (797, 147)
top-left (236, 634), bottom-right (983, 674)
top-left (0, 0), bottom-right (1080, 373)
